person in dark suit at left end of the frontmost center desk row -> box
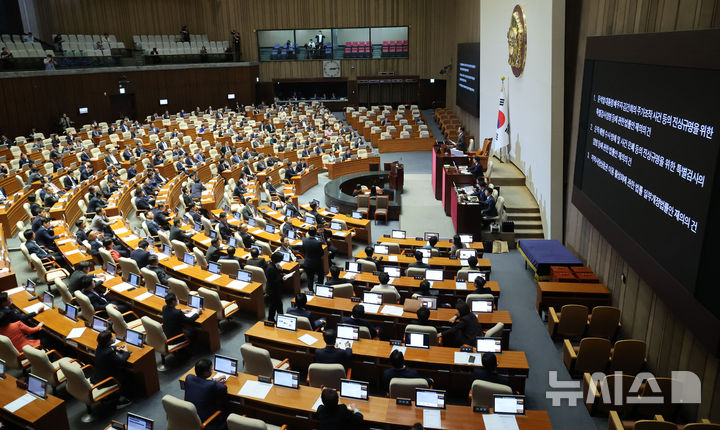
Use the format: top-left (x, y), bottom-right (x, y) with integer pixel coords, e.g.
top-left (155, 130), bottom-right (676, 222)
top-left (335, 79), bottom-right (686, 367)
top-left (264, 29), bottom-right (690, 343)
top-left (185, 358), bottom-right (227, 430)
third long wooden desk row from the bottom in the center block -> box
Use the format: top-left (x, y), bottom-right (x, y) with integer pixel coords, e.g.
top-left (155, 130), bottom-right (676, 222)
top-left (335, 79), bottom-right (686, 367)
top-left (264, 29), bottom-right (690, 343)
top-left (293, 296), bottom-right (512, 350)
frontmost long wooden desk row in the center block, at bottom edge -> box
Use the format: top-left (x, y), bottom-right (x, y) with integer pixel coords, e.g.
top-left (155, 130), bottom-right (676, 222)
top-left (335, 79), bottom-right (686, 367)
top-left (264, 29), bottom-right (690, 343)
top-left (180, 371), bottom-right (552, 430)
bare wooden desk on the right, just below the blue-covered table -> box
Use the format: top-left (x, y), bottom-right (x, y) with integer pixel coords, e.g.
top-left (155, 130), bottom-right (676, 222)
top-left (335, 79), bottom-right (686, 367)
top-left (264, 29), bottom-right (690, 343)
top-left (535, 282), bottom-right (612, 314)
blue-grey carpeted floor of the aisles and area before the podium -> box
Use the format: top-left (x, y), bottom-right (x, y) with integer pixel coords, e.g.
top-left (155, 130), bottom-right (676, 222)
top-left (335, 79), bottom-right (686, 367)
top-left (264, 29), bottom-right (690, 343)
top-left (2, 109), bottom-right (607, 429)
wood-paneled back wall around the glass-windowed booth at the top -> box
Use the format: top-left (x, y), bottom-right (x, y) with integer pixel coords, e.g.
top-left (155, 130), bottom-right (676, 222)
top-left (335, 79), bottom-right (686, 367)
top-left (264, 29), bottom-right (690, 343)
top-left (36, 0), bottom-right (456, 81)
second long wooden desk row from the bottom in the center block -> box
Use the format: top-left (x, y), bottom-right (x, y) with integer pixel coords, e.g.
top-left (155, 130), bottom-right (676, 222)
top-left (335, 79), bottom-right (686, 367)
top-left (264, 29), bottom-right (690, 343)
top-left (245, 321), bottom-right (530, 397)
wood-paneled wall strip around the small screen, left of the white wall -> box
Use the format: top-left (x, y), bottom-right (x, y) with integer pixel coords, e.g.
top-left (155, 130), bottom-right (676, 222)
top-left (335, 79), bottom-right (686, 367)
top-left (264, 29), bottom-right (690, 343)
top-left (441, 0), bottom-right (482, 137)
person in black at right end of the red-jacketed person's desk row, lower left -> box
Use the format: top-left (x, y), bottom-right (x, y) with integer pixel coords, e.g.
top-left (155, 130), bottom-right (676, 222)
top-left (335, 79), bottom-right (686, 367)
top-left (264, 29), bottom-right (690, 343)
top-left (90, 330), bottom-right (130, 408)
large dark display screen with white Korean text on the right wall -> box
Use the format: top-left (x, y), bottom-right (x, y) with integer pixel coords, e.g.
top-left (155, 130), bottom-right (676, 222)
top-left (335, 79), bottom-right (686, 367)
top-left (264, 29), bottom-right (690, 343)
top-left (572, 30), bottom-right (720, 353)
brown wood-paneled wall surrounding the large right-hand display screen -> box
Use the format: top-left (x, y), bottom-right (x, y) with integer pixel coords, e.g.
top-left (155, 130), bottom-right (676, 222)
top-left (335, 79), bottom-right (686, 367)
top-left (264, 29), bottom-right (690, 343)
top-left (565, 0), bottom-right (720, 422)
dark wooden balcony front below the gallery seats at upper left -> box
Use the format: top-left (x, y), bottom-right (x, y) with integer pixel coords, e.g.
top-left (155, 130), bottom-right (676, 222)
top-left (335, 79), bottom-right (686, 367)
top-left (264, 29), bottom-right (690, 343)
top-left (0, 66), bottom-right (258, 137)
